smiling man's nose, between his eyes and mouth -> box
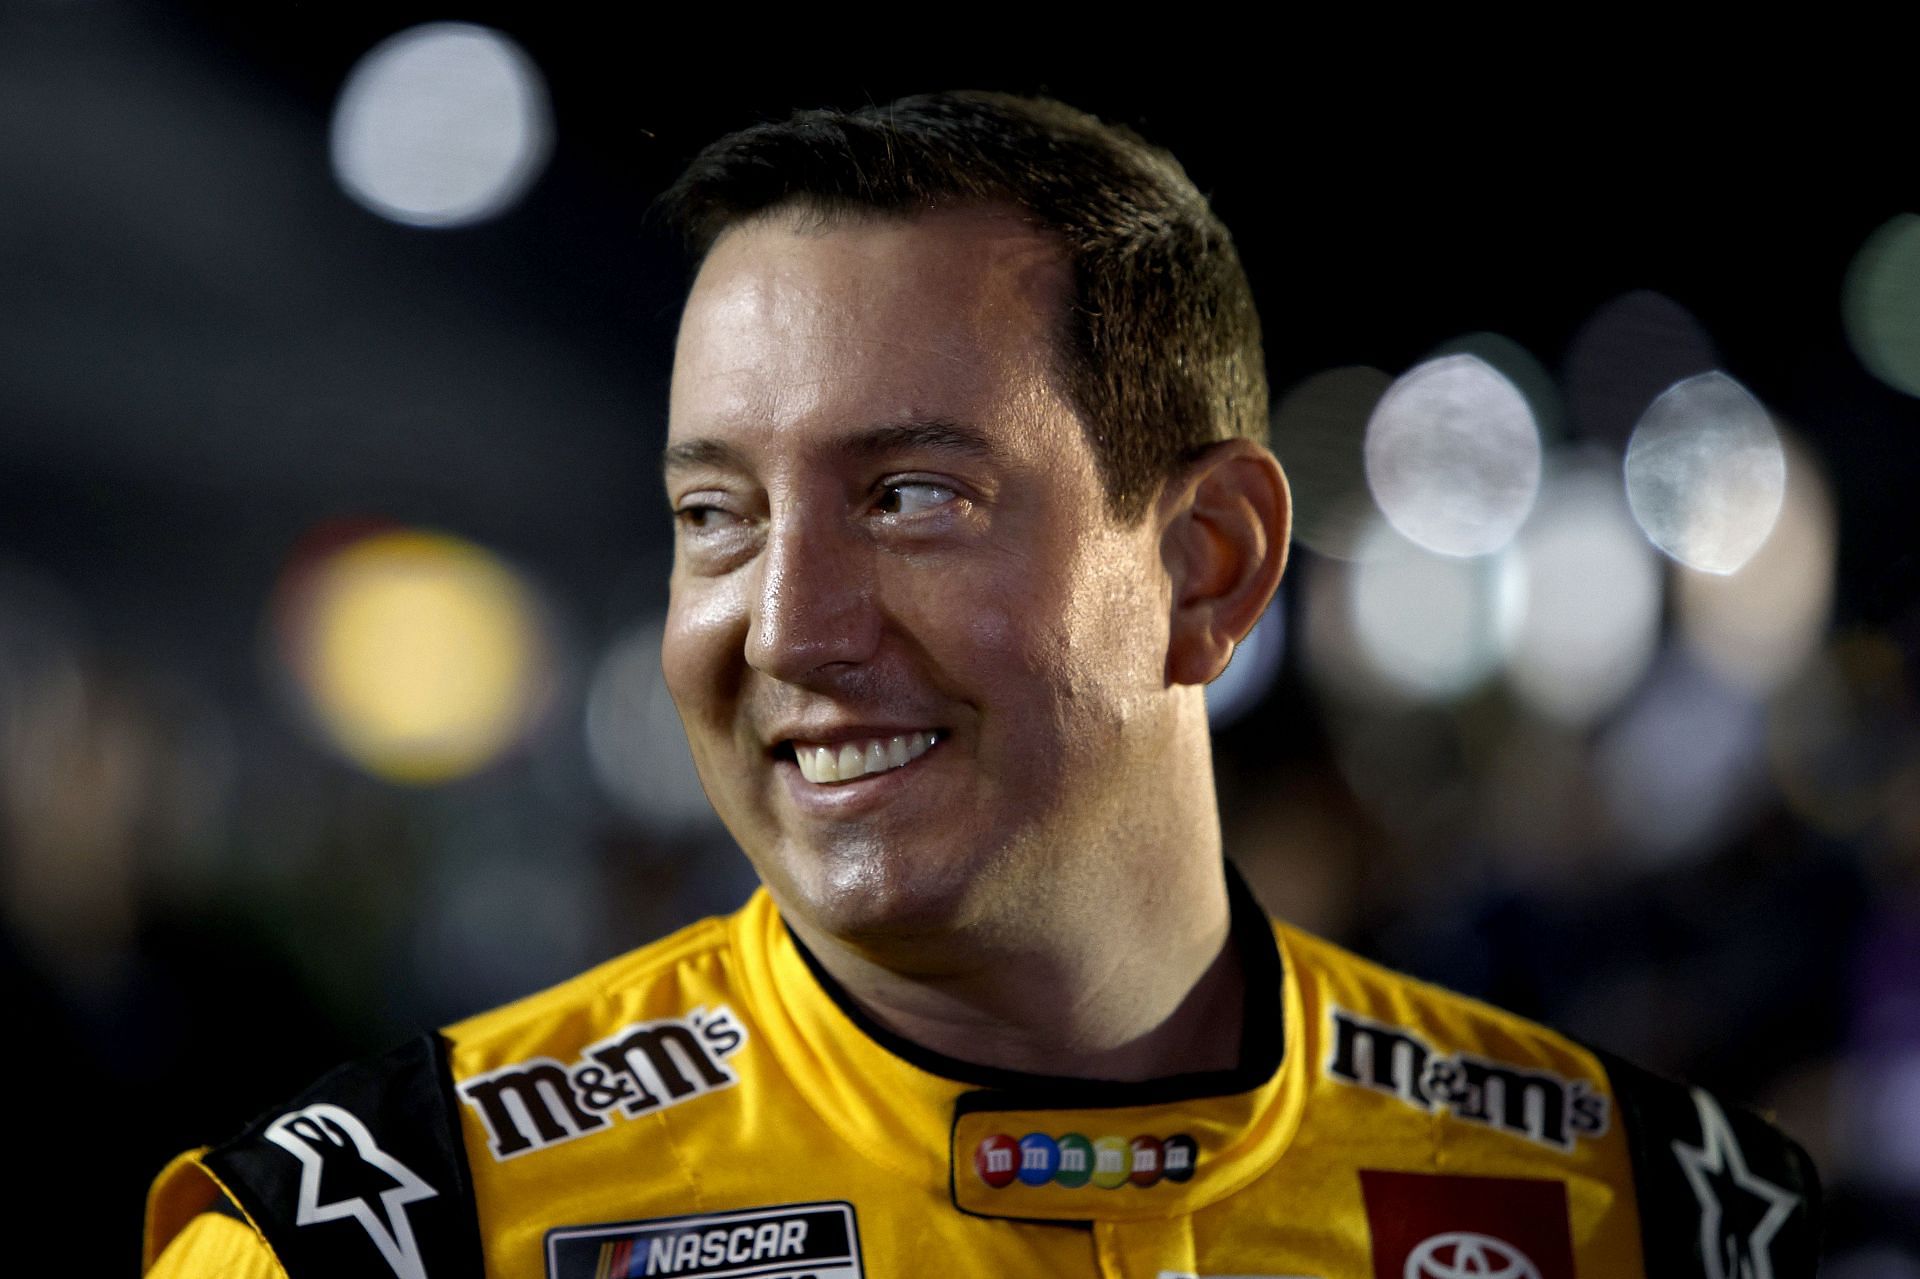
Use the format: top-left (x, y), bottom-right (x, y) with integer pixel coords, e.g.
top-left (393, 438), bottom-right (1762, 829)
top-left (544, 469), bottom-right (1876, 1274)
top-left (747, 513), bottom-right (879, 684)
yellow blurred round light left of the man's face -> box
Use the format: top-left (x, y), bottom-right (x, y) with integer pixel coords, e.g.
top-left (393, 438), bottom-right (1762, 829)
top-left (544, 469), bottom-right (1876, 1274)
top-left (288, 532), bottom-right (543, 784)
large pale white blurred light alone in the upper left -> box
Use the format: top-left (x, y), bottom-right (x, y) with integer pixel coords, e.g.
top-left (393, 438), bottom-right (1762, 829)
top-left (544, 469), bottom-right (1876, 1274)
top-left (332, 23), bottom-right (553, 227)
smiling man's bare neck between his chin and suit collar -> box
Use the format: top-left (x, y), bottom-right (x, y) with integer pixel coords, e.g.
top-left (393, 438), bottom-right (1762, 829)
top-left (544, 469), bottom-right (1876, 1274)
top-left (779, 858), bottom-right (1246, 1081)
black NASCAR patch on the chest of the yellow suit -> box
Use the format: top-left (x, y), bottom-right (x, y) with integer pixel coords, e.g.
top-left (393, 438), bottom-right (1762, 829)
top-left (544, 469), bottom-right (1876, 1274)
top-left (547, 1202), bottom-right (866, 1279)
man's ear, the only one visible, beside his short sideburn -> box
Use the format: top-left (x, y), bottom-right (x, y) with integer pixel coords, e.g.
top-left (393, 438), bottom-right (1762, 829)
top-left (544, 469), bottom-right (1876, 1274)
top-left (1158, 440), bottom-right (1292, 684)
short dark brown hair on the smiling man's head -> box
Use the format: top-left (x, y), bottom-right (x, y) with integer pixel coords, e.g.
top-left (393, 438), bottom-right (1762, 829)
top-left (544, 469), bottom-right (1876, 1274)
top-left (660, 92), bottom-right (1267, 520)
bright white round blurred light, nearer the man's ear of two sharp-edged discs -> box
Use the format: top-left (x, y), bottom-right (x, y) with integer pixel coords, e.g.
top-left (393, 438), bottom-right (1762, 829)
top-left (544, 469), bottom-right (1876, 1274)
top-left (1367, 355), bottom-right (1540, 555)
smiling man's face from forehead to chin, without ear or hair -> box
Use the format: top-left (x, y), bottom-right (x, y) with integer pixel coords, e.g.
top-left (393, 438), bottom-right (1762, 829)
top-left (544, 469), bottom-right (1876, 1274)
top-left (662, 207), bottom-right (1171, 939)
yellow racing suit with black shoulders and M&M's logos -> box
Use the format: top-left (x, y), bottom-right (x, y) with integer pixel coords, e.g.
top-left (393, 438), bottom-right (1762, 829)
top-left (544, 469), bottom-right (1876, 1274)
top-left (146, 880), bottom-right (1818, 1279)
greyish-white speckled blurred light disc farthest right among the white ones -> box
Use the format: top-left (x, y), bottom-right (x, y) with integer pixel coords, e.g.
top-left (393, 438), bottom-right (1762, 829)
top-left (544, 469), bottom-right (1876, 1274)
top-left (1626, 371), bottom-right (1786, 572)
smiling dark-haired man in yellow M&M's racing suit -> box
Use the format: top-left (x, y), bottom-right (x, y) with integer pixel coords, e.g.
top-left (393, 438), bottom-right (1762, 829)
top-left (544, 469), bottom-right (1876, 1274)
top-left (150, 94), bottom-right (1816, 1279)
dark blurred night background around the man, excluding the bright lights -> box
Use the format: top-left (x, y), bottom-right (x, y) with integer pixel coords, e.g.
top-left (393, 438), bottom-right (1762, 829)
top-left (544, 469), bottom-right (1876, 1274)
top-left (0, 0), bottom-right (1920, 1275)
